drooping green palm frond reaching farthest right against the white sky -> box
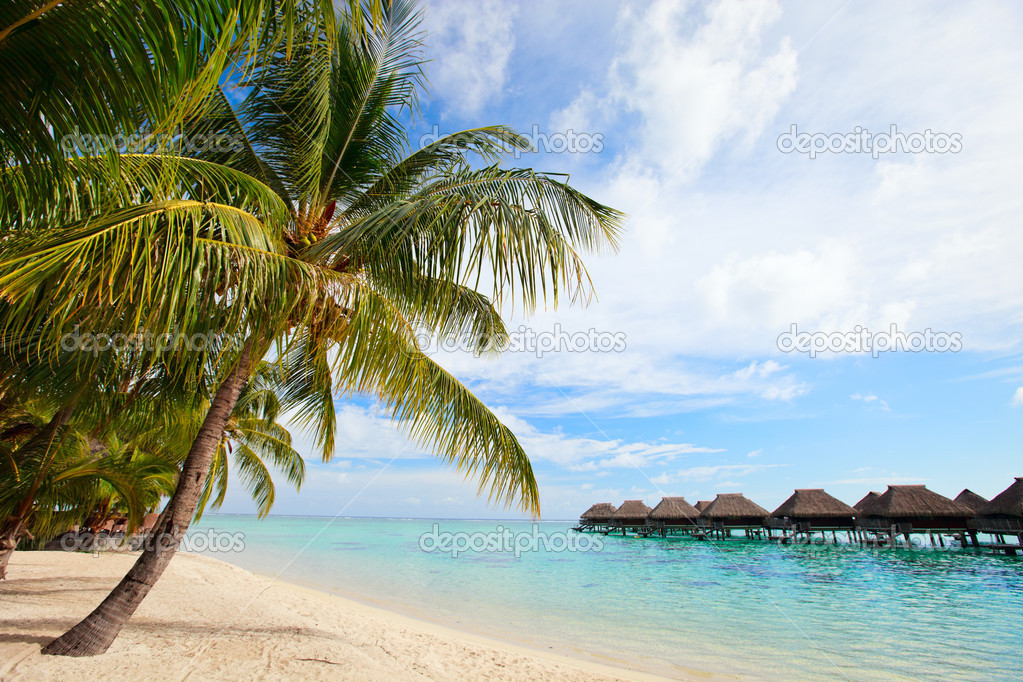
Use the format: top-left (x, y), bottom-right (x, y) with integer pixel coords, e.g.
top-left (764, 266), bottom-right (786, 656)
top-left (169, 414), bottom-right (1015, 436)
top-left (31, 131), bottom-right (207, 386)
top-left (319, 167), bottom-right (622, 311)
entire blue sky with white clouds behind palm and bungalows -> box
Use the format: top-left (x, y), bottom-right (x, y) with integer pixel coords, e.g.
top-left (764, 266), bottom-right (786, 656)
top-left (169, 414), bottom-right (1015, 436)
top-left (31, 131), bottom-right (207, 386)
top-left (217, 0), bottom-right (1023, 518)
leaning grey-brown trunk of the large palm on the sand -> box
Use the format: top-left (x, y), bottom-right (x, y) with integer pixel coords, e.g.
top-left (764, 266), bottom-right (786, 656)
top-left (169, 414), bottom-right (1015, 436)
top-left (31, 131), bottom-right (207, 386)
top-left (43, 343), bottom-right (252, 656)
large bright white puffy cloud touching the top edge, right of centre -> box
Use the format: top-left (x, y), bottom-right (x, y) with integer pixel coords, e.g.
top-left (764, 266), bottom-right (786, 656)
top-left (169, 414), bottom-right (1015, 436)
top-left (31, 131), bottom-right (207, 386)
top-left (597, 0), bottom-right (796, 178)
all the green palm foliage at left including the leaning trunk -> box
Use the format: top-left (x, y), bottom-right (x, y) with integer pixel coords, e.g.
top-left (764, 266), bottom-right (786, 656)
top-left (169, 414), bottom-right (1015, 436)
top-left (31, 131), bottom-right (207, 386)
top-left (0, 0), bottom-right (622, 655)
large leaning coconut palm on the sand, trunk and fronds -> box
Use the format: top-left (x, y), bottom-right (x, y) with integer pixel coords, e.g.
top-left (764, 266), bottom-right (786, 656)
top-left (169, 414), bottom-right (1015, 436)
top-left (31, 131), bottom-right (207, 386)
top-left (0, 2), bottom-right (620, 655)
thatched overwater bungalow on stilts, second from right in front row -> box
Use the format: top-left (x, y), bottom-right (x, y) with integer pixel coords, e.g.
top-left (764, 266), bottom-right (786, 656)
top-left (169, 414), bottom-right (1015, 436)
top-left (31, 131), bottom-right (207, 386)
top-left (856, 486), bottom-right (976, 546)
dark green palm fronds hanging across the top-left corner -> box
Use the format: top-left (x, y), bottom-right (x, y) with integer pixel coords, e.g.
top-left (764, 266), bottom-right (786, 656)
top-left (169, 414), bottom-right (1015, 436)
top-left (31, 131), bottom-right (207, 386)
top-left (0, 0), bottom-right (372, 178)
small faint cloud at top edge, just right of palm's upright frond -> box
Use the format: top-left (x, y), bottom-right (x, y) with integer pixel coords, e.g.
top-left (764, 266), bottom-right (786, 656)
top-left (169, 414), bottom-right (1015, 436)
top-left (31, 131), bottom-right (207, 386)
top-left (425, 0), bottom-right (516, 116)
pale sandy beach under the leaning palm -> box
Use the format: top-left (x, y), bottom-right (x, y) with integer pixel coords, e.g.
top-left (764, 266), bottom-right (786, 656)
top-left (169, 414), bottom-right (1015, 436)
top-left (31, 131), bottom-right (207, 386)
top-left (0, 552), bottom-right (687, 681)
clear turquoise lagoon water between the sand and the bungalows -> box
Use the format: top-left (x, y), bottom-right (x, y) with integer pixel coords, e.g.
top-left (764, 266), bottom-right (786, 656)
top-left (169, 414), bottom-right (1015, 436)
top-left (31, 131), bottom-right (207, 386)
top-left (188, 514), bottom-right (1023, 680)
